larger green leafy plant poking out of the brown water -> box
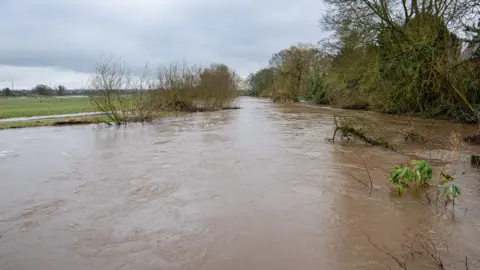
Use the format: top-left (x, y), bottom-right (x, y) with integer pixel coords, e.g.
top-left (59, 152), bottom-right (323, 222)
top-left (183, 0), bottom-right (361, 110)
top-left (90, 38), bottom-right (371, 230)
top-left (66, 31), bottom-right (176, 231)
top-left (390, 160), bottom-right (432, 196)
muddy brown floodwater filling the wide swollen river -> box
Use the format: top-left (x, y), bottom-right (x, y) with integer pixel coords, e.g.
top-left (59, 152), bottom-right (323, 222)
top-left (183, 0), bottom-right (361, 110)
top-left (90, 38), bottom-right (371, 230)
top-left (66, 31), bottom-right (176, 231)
top-left (0, 98), bottom-right (480, 270)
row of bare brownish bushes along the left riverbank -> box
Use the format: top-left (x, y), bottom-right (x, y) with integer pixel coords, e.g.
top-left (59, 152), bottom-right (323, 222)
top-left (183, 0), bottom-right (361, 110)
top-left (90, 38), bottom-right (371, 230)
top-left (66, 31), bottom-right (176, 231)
top-left (89, 59), bottom-right (239, 125)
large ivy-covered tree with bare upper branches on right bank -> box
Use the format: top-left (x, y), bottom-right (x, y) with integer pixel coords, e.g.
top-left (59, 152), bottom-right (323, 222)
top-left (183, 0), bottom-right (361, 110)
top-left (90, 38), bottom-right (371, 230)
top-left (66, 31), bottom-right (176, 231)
top-left (323, 0), bottom-right (479, 119)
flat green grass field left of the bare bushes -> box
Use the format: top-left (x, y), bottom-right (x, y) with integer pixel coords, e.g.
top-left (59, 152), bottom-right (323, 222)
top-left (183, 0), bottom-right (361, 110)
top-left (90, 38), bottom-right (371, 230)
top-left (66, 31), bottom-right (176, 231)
top-left (0, 97), bottom-right (95, 119)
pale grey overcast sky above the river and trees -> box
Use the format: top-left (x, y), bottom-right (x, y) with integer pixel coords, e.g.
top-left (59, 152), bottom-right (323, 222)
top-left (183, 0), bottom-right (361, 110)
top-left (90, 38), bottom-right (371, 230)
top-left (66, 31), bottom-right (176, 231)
top-left (0, 0), bottom-right (323, 89)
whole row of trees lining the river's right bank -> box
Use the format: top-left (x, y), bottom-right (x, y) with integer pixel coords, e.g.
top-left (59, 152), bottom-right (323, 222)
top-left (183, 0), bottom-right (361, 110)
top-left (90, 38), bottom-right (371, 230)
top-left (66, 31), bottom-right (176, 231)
top-left (247, 0), bottom-right (480, 122)
